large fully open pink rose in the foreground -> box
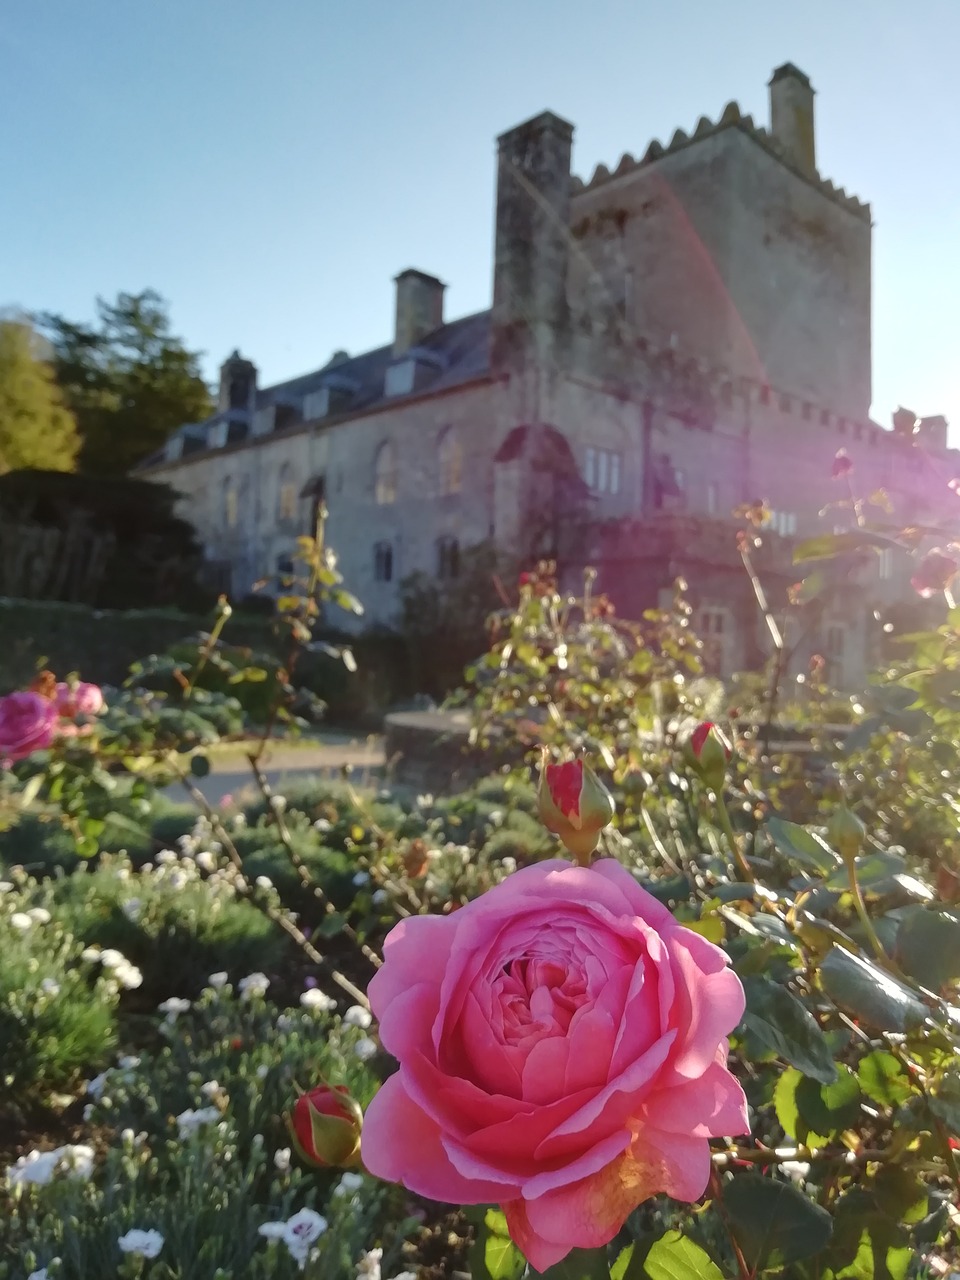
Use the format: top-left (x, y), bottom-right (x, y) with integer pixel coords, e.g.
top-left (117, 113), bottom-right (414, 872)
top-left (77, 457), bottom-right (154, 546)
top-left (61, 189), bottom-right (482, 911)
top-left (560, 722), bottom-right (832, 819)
top-left (362, 859), bottom-right (749, 1271)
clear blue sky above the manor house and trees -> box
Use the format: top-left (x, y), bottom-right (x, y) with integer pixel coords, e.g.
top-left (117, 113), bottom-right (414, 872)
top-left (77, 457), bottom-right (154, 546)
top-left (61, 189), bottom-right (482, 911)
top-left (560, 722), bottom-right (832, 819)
top-left (0, 0), bottom-right (960, 442)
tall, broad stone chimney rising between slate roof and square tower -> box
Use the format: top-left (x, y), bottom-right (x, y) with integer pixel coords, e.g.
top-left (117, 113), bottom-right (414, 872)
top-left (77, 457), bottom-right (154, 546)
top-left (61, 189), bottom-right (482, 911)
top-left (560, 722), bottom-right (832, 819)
top-left (490, 111), bottom-right (573, 367)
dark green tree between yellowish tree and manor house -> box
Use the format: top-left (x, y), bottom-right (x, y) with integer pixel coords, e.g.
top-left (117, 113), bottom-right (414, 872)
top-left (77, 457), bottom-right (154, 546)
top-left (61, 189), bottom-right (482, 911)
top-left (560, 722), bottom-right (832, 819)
top-left (42, 289), bottom-right (212, 475)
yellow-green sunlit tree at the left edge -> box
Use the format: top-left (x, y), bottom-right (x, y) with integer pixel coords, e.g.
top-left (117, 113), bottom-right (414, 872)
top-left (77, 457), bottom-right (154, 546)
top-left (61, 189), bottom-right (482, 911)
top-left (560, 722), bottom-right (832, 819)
top-left (0, 319), bottom-right (81, 472)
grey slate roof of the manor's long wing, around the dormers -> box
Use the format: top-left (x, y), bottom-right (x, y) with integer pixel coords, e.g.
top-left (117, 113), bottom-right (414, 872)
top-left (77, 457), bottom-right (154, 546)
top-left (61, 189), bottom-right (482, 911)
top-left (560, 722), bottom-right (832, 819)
top-left (140, 311), bottom-right (490, 467)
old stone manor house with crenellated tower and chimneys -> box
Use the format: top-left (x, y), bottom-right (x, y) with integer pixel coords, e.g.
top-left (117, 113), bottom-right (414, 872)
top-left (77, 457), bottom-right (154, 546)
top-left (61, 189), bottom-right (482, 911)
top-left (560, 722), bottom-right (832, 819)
top-left (141, 63), bottom-right (960, 686)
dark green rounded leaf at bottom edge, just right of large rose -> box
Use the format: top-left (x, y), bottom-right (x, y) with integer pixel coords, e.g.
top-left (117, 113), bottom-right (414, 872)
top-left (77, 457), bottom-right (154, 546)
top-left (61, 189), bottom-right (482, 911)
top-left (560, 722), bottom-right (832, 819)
top-left (723, 1172), bottom-right (833, 1270)
